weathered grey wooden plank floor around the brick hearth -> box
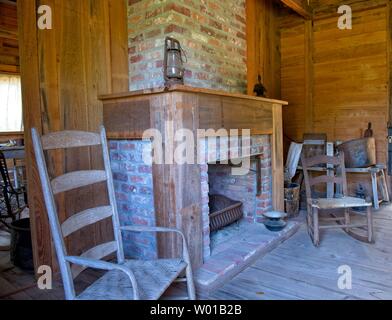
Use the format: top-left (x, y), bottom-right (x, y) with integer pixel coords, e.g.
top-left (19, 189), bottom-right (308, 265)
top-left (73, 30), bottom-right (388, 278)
top-left (0, 206), bottom-right (392, 300)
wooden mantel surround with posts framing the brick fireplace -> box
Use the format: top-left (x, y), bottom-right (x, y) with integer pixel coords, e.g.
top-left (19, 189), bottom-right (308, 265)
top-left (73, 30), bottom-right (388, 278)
top-left (100, 85), bottom-right (288, 268)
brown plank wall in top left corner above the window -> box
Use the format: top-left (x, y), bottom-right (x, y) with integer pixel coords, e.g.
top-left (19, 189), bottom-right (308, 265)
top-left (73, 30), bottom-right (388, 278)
top-left (0, 0), bottom-right (19, 74)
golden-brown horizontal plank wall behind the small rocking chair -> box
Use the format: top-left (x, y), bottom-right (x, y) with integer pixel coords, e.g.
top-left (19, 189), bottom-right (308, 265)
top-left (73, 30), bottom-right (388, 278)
top-left (281, 0), bottom-right (390, 192)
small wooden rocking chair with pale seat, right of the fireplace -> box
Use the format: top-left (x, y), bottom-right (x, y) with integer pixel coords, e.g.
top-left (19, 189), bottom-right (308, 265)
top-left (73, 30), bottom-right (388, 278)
top-left (302, 153), bottom-right (373, 246)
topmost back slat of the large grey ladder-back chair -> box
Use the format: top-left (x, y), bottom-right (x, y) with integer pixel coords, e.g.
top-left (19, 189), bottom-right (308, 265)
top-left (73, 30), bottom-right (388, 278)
top-left (41, 131), bottom-right (101, 150)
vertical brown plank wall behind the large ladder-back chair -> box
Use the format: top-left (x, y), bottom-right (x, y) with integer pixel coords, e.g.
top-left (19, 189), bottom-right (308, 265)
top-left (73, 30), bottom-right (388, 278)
top-left (18, 0), bottom-right (128, 267)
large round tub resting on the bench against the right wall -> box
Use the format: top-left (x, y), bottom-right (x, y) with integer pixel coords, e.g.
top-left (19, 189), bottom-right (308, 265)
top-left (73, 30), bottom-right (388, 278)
top-left (337, 138), bottom-right (377, 168)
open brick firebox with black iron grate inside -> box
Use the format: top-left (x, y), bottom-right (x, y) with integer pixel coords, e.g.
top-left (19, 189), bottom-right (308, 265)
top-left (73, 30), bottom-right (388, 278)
top-left (200, 136), bottom-right (272, 261)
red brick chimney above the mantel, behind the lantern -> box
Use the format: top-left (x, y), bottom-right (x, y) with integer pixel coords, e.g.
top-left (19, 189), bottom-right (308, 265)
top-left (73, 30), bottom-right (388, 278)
top-left (128, 0), bottom-right (247, 93)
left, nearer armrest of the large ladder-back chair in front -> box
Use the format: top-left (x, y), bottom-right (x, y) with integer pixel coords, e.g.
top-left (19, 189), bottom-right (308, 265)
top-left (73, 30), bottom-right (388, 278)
top-left (65, 256), bottom-right (140, 300)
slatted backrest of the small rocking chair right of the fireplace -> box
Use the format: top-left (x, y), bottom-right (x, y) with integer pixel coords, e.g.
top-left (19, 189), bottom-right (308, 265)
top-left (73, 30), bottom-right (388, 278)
top-left (301, 152), bottom-right (348, 199)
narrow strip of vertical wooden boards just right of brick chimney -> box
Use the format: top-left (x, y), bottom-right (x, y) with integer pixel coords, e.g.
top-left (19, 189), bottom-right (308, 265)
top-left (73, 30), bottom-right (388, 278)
top-left (246, 0), bottom-right (281, 99)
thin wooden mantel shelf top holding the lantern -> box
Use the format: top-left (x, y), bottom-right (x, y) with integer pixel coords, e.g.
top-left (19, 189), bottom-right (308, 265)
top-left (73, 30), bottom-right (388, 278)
top-left (99, 85), bottom-right (288, 106)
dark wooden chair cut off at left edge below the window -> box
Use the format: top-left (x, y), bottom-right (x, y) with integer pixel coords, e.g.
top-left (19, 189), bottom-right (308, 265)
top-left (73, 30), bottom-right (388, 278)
top-left (0, 151), bottom-right (27, 228)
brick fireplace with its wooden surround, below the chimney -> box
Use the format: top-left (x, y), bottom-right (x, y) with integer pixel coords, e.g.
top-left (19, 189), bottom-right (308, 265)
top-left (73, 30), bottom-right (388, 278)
top-left (101, 86), bottom-right (285, 270)
